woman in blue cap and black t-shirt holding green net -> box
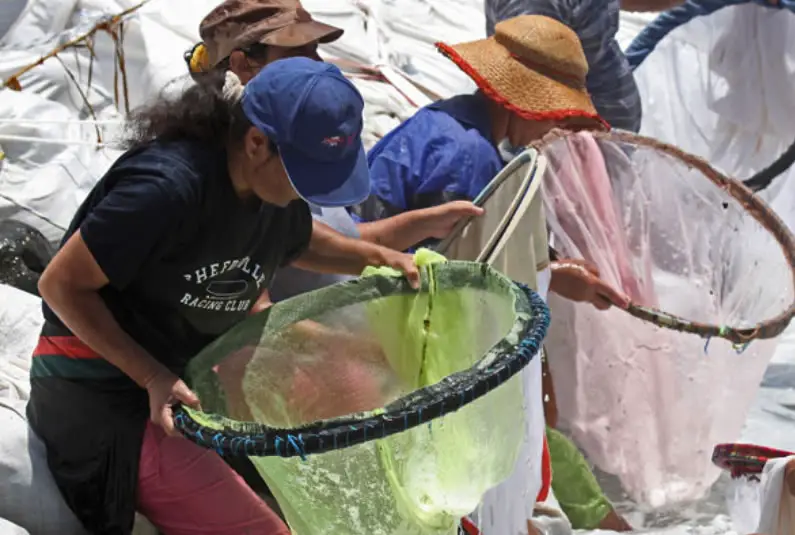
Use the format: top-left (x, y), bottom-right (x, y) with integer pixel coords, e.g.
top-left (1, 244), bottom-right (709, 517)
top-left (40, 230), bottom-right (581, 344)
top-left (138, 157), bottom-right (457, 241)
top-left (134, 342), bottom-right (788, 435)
top-left (28, 58), bottom-right (418, 535)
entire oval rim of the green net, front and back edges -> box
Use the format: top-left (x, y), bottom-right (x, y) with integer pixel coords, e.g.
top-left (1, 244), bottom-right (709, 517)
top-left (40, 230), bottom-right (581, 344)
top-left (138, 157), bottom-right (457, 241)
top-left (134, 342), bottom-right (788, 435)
top-left (173, 261), bottom-right (549, 457)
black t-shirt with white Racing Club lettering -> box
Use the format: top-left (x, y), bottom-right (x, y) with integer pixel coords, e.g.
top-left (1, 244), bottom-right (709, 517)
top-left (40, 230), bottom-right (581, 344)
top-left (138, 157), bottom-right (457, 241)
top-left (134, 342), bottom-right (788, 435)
top-left (34, 138), bottom-right (312, 379)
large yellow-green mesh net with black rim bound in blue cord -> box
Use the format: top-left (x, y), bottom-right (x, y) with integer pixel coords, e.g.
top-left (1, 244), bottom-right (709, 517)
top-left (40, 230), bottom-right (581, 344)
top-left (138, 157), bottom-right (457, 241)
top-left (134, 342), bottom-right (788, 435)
top-left (175, 256), bottom-right (549, 535)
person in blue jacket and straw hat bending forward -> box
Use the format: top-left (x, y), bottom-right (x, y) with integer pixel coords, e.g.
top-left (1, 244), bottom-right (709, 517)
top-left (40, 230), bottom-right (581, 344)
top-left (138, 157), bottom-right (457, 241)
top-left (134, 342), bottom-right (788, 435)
top-left (355, 15), bottom-right (609, 221)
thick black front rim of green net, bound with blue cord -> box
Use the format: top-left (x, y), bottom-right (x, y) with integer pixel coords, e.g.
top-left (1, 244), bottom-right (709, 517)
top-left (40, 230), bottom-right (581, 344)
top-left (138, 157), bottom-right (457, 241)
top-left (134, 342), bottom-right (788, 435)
top-left (174, 265), bottom-right (550, 458)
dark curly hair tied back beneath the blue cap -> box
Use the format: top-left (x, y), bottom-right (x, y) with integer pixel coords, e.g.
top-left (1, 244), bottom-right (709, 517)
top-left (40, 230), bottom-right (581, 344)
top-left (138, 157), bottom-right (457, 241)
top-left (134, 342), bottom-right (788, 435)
top-left (123, 72), bottom-right (251, 148)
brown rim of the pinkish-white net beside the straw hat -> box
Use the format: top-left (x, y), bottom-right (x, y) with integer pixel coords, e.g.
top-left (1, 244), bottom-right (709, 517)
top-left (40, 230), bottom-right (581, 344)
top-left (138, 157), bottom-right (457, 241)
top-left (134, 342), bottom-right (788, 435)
top-left (530, 129), bottom-right (795, 344)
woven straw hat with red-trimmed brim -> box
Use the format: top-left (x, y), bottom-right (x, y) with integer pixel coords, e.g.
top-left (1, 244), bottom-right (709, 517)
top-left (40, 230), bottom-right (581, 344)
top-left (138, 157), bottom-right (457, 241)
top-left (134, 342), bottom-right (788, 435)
top-left (436, 15), bottom-right (609, 129)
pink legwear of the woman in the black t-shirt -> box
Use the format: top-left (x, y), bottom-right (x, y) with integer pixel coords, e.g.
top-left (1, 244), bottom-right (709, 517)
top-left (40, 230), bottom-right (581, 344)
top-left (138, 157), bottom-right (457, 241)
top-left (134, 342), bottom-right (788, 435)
top-left (138, 422), bottom-right (290, 535)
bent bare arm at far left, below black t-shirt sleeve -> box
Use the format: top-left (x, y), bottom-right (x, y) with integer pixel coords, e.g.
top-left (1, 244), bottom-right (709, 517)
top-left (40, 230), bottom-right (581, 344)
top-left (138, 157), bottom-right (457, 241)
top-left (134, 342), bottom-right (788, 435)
top-left (39, 231), bottom-right (165, 388)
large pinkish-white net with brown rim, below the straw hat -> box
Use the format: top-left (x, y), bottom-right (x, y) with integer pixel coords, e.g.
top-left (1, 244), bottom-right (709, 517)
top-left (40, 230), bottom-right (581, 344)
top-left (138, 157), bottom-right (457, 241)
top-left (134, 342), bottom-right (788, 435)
top-left (536, 132), bottom-right (795, 507)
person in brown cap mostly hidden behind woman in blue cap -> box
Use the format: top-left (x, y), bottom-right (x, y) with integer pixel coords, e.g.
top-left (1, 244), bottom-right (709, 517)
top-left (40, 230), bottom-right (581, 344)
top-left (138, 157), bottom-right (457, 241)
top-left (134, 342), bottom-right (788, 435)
top-left (186, 0), bottom-right (483, 308)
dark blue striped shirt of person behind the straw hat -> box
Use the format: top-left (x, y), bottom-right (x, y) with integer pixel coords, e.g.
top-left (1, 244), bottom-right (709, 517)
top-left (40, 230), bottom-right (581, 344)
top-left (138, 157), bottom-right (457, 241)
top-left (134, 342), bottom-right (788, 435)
top-left (486, 0), bottom-right (641, 132)
